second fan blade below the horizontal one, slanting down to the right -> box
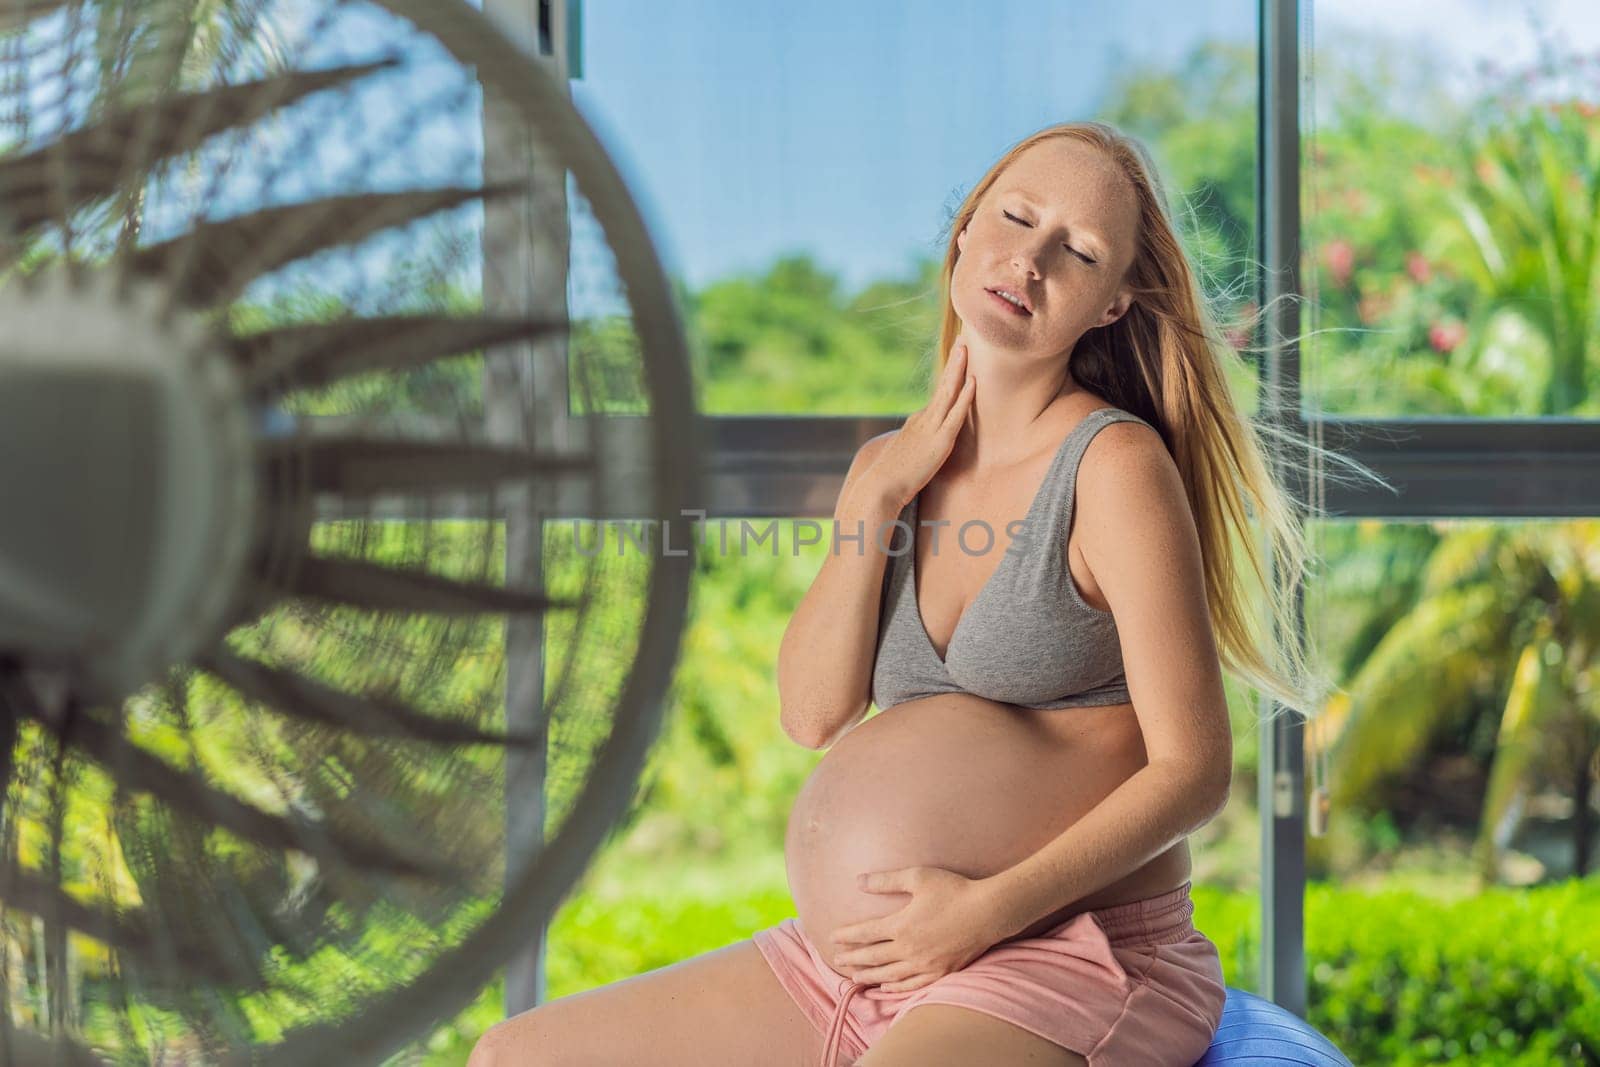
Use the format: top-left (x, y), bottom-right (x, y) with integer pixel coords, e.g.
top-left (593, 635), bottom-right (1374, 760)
top-left (198, 651), bottom-right (538, 747)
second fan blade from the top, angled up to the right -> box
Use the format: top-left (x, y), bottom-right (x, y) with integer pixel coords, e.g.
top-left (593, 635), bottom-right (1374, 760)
top-left (128, 181), bottom-right (525, 307)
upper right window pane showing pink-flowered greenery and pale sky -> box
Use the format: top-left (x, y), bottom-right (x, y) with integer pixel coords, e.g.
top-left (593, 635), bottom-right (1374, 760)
top-left (1302, 0), bottom-right (1600, 418)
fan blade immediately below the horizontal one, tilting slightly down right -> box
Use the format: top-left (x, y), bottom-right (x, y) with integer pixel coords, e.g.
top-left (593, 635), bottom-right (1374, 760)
top-left (285, 557), bottom-right (578, 614)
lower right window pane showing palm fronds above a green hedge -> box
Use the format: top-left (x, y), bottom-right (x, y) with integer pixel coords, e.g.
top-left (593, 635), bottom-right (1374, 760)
top-left (1306, 520), bottom-right (1600, 1064)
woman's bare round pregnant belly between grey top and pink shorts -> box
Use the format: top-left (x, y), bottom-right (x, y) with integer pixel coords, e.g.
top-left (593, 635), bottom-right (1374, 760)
top-left (784, 693), bottom-right (1146, 966)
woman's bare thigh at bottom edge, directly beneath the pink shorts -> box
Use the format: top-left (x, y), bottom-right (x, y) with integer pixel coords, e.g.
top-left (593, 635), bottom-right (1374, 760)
top-left (856, 1005), bottom-right (1088, 1067)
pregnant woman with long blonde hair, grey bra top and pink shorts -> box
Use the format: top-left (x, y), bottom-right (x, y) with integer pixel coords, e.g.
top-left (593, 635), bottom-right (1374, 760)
top-left (470, 122), bottom-right (1331, 1067)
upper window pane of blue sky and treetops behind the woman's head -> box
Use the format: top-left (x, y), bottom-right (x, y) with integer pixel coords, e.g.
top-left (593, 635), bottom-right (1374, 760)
top-left (573, 0), bottom-right (1256, 414)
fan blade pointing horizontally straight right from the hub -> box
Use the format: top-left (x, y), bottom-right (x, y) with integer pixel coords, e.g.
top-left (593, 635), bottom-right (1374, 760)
top-left (261, 435), bottom-right (590, 496)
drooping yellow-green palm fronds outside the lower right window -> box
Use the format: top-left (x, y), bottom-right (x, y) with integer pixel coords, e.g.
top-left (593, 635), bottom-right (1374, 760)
top-left (1307, 522), bottom-right (1600, 883)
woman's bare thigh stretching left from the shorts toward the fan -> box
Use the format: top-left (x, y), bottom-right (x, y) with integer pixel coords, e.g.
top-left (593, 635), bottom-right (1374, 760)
top-left (467, 941), bottom-right (822, 1067)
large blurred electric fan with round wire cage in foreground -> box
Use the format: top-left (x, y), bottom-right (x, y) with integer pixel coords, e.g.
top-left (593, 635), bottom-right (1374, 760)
top-left (0, 0), bottom-right (701, 1067)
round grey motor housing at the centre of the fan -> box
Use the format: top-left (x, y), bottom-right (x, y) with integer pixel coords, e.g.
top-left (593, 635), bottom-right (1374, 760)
top-left (0, 264), bottom-right (256, 699)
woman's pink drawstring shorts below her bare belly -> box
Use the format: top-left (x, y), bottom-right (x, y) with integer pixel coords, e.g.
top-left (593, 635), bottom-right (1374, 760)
top-left (755, 881), bottom-right (1226, 1067)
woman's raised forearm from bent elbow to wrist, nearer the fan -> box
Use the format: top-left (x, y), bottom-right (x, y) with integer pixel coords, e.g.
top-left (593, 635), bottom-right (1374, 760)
top-left (778, 430), bottom-right (904, 749)
